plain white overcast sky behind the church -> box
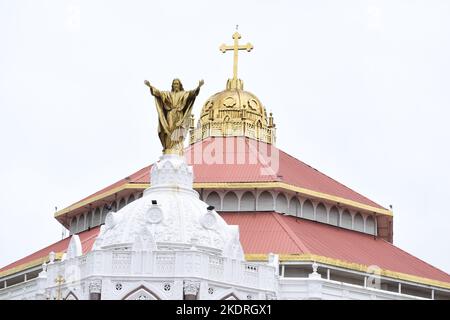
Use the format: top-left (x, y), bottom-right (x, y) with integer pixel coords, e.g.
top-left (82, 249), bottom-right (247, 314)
top-left (0, 0), bottom-right (450, 272)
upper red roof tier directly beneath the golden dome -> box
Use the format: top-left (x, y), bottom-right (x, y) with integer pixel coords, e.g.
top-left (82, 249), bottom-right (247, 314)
top-left (67, 137), bottom-right (384, 209)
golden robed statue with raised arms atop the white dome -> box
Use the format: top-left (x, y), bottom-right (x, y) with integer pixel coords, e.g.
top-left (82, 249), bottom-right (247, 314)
top-left (144, 79), bottom-right (204, 155)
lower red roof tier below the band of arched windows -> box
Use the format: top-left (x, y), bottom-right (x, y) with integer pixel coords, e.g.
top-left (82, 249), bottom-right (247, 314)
top-left (0, 212), bottom-right (450, 284)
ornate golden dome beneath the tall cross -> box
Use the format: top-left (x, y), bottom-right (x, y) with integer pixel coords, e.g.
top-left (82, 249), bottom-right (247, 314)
top-left (190, 79), bottom-right (275, 143)
